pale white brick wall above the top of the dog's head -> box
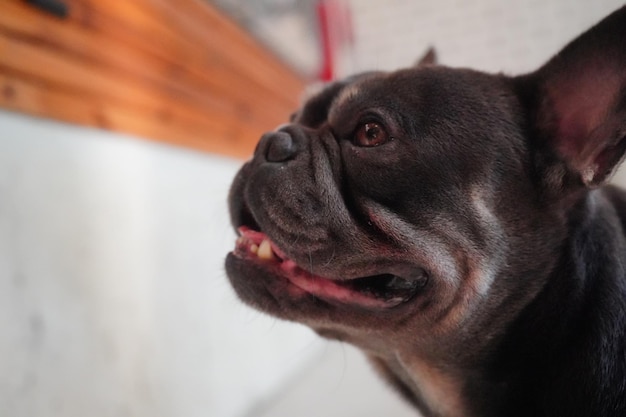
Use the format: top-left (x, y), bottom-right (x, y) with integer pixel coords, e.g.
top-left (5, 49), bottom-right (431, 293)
top-left (348, 0), bottom-right (624, 74)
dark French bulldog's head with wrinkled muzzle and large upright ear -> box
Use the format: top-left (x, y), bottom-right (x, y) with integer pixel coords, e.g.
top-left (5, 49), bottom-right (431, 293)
top-left (226, 9), bottom-right (626, 354)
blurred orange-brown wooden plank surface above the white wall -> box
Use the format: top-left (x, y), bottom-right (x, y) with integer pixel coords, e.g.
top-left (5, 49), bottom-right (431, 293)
top-left (0, 0), bottom-right (305, 157)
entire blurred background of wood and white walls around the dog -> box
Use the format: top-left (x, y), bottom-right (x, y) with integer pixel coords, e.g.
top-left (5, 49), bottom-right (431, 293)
top-left (0, 0), bottom-right (623, 417)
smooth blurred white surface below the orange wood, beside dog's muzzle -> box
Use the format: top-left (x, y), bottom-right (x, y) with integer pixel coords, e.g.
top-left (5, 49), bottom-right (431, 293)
top-left (0, 112), bottom-right (318, 417)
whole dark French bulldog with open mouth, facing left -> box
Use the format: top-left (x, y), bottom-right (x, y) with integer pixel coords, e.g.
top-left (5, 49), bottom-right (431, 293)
top-left (226, 8), bottom-right (626, 417)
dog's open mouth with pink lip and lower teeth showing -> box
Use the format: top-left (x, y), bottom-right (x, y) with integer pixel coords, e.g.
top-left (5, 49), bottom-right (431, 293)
top-left (234, 226), bottom-right (427, 308)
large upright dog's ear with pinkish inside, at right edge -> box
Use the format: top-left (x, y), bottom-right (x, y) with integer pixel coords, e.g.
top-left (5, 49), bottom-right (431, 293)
top-left (519, 7), bottom-right (626, 187)
